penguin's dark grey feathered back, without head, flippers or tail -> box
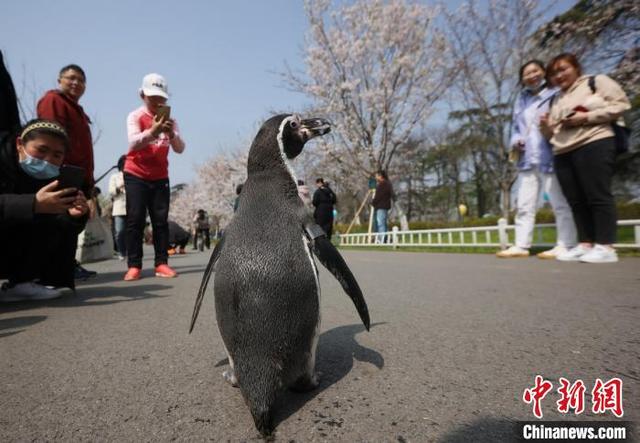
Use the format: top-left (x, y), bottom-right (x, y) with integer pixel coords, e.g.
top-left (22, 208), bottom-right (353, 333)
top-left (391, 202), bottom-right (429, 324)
top-left (214, 168), bottom-right (319, 391)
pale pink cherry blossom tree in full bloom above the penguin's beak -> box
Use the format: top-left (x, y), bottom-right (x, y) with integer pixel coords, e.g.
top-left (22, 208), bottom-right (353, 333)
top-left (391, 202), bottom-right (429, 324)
top-left (283, 0), bottom-right (452, 183)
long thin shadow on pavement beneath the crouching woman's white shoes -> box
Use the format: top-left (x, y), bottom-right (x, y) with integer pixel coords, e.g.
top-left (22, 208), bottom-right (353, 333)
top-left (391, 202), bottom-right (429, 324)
top-left (2, 284), bottom-right (171, 313)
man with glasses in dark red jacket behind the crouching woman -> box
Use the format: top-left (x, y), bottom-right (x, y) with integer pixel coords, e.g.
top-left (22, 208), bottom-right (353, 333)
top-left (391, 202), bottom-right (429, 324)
top-left (37, 64), bottom-right (96, 280)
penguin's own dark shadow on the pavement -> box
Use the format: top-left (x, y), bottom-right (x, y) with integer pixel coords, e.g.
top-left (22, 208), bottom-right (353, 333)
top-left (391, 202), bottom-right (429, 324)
top-left (275, 322), bottom-right (385, 426)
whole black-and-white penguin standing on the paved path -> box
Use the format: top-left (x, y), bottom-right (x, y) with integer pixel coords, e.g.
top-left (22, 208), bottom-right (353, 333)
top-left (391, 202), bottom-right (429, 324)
top-left (189, 114), bottom-right (370, 437)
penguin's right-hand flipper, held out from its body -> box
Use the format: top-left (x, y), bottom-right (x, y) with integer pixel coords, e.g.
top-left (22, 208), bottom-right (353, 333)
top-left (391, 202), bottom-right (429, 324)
top-left (306, 225), bottom-right (370, 331)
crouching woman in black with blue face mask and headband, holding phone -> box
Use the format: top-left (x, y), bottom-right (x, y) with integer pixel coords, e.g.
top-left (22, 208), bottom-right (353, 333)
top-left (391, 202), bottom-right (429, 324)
top-left (0, 120), bottom-right (88, 302)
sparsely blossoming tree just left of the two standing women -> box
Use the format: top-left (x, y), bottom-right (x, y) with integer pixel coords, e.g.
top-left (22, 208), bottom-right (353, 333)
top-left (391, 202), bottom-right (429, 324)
top-left (445, 0), bottom-right (543, 217)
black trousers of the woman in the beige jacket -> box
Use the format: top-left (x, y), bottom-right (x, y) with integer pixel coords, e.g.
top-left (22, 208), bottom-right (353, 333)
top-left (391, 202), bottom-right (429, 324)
top-left (554, 138), bottom-right (617, 245)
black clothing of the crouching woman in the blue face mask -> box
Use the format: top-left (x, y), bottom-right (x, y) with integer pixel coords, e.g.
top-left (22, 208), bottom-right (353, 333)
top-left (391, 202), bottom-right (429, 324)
top-left (0, 133), bottom-right (87, 288)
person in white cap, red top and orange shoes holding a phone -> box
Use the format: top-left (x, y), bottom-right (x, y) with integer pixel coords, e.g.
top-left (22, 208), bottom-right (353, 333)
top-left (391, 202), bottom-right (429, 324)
top-left (124, 74), bottom-right (185, 281)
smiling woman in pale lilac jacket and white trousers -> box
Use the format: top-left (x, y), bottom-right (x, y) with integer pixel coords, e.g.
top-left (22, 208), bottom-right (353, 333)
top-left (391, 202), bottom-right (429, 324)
top-left (497, 60), bottom-right (576, 259)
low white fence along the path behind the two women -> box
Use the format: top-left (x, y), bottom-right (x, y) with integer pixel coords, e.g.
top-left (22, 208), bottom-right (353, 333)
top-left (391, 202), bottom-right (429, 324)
top-left (340, 218), bottom-right (640, 249)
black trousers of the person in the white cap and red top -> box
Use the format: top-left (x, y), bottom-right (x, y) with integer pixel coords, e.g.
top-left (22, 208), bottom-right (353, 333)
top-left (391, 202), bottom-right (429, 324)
top-left (124, 173), bottom-right (170, 268)
